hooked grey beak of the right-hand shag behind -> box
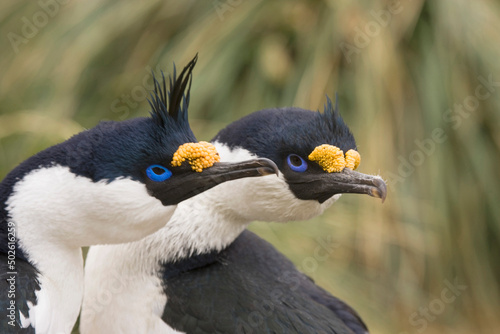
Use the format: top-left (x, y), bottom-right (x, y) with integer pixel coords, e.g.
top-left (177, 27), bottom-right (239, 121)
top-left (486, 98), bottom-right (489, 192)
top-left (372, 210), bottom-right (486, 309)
top-left (289, 168), bottom-right (387, 203)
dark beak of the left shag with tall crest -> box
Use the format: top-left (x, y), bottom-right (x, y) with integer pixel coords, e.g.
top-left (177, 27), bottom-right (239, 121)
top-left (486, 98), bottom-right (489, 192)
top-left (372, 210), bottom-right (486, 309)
top-left (148, 158), bottom-right (279, 206)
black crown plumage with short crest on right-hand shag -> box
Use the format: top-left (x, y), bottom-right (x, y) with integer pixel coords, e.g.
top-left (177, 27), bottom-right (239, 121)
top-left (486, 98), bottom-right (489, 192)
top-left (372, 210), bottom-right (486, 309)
top-left (213, 97), bottom-right (356, 166)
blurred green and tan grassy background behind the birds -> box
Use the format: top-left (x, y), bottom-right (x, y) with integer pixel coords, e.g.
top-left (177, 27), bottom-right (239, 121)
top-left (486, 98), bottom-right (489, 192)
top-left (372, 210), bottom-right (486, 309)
top-left (0, 0), bottom-right (500, 334)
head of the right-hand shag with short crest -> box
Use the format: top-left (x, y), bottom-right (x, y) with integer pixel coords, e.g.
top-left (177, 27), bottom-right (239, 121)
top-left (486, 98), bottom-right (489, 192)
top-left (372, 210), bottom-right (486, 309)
top-left (213, 99), bottom-right (387, 221)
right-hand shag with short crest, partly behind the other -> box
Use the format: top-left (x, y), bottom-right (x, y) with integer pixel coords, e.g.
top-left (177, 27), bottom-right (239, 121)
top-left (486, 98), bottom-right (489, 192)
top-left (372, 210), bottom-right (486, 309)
top-left (80, 61), bottom-right (386, 334)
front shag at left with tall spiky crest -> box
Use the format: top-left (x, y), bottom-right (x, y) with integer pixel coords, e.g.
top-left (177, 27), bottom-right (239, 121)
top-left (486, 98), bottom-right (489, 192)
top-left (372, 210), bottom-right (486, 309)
top-left (0, 57), bottom-right (277, 334)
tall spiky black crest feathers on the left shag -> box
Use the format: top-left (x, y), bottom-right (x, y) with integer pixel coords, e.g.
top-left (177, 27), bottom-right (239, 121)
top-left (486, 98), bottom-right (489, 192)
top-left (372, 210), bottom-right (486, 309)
top-left (148, 54), bottom-right (198, 127)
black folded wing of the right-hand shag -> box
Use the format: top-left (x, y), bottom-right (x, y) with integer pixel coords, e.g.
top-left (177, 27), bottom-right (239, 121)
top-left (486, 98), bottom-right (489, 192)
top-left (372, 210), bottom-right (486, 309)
top-left (162, 231), bottom-right (365, 334)
